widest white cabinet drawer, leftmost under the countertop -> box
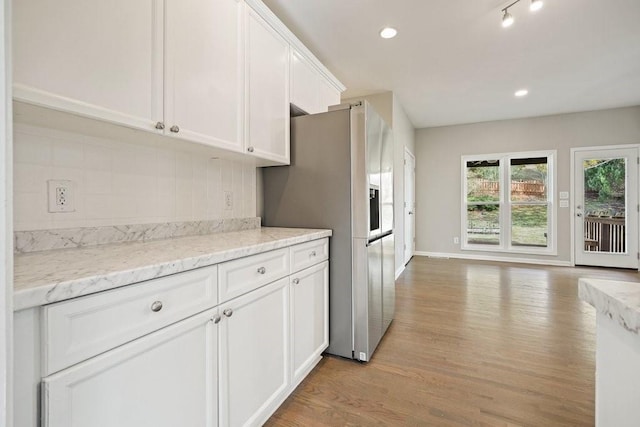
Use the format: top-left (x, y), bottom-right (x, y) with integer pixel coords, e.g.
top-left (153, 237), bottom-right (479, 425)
top-left (43, 266), bottom-right (218, 375)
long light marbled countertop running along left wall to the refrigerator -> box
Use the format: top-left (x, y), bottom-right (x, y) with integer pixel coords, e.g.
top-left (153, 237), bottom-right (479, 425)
top-left (13, 227), bottom-right (332, 311)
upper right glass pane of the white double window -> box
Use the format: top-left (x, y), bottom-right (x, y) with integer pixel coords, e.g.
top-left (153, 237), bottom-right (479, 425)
top-left (510, 157), bottom-right (548, 202)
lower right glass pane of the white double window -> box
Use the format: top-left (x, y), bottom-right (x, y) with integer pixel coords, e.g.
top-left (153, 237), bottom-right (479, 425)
top-left (511, 205), bottom-right (548, 248)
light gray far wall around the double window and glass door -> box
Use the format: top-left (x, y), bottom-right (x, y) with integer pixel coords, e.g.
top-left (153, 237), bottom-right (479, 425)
top-left (415, 106), bottom-right (640, 262)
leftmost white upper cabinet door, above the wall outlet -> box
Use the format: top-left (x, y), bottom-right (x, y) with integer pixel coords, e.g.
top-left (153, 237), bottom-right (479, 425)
top-left (13, 0), bottom-right (163, 129)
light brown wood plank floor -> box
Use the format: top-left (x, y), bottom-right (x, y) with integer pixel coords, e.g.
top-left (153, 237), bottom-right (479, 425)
top-left (266, 257), bottom-right (640, 427)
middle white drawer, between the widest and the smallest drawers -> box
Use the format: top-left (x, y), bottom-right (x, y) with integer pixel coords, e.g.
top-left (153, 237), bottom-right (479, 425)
top-left (218, 248), bottom-right (290, 303)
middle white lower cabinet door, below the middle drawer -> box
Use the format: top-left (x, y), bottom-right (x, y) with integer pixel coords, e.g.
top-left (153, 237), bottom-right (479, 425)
top-left (220, 278), bottom-right (290, 426)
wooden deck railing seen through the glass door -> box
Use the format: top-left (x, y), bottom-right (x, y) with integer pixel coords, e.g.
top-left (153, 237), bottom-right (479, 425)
top-left (584, 216), bottom-right (627, 253)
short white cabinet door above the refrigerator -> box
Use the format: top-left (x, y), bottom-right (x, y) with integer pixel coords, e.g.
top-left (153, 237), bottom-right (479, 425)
top-left (291, 50), bottom-right (326, 114)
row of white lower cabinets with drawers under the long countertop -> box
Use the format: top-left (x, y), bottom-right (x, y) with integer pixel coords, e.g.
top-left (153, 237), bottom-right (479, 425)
top-left (26, 239), bottom-right (329, 427)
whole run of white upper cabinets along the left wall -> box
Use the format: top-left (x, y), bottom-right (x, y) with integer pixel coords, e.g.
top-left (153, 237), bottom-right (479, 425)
top-left (12, 0), bottom-right (344, 166)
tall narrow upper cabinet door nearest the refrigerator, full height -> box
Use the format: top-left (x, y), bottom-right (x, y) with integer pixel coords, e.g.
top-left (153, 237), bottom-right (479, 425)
top-left (245, 7), bottom-right (289, 164)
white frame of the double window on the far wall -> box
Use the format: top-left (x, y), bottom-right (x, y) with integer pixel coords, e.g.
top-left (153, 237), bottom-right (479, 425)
top-left (460, 150), bottom-right (558, 255)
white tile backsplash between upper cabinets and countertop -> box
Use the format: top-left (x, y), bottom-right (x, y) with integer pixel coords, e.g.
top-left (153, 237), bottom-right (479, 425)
top-left (14, 124), bottom-right (256, 231)
